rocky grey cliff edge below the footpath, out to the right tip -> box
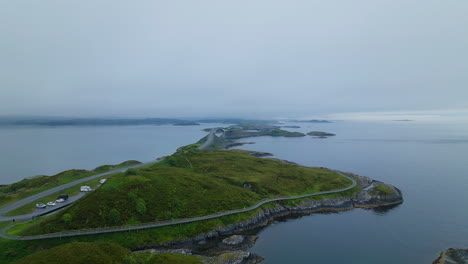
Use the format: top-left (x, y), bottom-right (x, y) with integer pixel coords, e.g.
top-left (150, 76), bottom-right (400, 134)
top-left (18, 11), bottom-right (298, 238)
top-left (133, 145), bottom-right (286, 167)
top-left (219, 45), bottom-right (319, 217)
top-left (142, 174), bottom-right (403, 250)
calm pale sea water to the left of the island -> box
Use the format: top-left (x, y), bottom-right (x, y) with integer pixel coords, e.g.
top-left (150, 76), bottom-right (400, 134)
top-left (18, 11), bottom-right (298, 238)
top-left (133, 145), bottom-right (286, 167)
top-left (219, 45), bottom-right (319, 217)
top-left (0, 124), bottom-right (221, 184)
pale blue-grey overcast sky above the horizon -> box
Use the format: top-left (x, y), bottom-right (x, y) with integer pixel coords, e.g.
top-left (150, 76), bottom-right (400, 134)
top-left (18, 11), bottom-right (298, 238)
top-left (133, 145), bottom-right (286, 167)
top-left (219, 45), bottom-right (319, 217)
top-left (0, 0), bottom-right (468, 118)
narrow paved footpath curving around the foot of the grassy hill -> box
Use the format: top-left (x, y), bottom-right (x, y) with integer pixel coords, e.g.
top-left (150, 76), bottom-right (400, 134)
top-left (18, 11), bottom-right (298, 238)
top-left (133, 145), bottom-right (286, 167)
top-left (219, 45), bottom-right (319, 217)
top-left (0, 170), bottom-right (356, 240)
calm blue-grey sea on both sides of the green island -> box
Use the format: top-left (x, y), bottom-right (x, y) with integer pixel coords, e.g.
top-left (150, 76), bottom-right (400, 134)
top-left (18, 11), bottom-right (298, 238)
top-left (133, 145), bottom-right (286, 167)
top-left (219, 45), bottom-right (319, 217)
top-left (0, 122), bottom-right (468, 264)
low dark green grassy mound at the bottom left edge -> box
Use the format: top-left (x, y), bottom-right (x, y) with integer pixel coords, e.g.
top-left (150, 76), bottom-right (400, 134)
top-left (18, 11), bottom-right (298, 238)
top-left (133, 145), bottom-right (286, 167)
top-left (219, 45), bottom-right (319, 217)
top-left (15, 242), bottom-right (130, 264)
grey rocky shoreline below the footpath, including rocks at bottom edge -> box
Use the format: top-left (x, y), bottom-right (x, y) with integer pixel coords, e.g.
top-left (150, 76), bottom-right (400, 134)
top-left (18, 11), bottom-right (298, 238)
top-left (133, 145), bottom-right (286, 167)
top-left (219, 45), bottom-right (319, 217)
top-left (135, 173), bottom-right (403, 264)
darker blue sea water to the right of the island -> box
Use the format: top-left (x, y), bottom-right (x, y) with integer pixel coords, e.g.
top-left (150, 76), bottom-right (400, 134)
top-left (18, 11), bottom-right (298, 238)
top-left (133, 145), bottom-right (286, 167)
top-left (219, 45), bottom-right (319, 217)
top-left (232, 122), bottom-right (468, 264)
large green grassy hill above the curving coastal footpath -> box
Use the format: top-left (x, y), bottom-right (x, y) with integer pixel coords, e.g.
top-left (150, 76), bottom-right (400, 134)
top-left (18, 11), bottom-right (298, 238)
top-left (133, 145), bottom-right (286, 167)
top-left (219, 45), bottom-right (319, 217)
top-left (16, 148), bottom-right (350, 234)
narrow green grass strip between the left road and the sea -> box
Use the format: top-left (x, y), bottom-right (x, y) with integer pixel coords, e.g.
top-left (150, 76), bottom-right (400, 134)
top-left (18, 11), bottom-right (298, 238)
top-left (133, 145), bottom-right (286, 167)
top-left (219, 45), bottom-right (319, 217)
top-left (0, 160), bottom-right (140, 206)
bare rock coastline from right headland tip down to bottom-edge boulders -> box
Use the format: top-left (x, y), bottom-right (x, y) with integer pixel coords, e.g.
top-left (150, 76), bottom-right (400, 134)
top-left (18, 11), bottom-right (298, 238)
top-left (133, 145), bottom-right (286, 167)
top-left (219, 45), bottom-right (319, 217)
top-left (132, 173), bottom-right (403, 264)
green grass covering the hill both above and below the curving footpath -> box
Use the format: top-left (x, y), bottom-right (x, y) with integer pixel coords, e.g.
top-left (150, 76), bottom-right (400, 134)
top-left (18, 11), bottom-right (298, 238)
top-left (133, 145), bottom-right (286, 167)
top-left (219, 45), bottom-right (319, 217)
top-left (0, 150), bottom-right (359, 264)
